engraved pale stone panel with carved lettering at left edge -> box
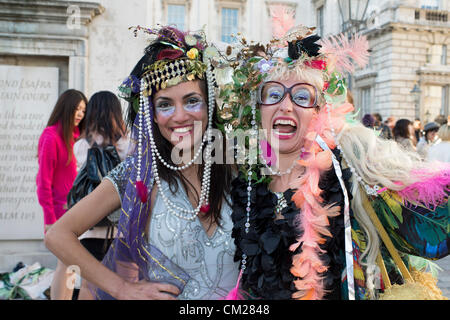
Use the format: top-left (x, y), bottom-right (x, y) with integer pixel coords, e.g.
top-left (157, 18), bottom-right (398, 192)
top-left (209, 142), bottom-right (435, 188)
top-left (0, 65), bottom-right (58, 240)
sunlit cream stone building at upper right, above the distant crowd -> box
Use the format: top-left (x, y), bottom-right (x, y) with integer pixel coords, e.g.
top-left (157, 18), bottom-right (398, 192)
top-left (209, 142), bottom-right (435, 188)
top-left (354, 1), bottom-right (450, 123)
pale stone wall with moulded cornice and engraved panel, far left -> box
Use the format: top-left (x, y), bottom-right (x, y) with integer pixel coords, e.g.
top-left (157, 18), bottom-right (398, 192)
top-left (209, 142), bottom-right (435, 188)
top-left (0, 0), bottom-right (103, 272)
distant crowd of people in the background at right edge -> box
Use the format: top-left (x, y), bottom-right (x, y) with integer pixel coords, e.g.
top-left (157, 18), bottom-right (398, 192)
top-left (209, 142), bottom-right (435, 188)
top-left (361, 113), bottom-right (450, 162)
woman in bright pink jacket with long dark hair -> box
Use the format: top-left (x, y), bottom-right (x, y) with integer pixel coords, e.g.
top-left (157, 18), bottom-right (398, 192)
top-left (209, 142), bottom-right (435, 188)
top-left (36, 89), bottom-right (87, 300)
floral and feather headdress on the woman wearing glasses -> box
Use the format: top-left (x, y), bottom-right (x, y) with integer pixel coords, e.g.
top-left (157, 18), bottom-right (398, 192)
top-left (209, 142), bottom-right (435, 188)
top-left (219, 26), bottom-right (368, 129)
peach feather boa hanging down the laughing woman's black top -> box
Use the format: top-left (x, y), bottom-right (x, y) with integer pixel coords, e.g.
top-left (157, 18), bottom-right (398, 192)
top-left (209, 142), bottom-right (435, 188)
top-left (289, 103), bottom-right (353, 300)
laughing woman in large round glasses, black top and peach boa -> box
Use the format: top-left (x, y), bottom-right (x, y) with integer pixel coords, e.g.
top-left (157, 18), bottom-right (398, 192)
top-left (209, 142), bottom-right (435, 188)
top-left (219, 18), bottom-right (450, 300)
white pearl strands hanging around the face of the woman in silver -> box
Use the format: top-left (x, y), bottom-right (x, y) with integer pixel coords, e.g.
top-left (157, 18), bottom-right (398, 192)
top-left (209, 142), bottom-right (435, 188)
top-left (136, 62), bottom-right (215, 221)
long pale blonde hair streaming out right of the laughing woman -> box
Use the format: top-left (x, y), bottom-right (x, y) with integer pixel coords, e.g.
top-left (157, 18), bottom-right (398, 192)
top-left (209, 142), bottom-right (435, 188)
top-left (337, 123), bottom-right (426, 298)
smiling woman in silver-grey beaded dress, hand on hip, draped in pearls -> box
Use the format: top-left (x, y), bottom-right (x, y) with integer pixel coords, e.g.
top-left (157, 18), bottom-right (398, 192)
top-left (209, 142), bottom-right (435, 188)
top-left (45, 27), bottom-right (238, 299)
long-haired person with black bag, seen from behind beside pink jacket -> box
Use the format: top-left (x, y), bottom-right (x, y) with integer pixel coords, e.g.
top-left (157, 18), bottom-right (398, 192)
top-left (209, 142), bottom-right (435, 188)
top-left (68, 91), bottom-right (129, 299)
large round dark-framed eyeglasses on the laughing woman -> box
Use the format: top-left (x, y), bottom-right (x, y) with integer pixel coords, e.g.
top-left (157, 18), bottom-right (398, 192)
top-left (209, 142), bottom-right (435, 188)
top-left (257, 81), bottom-right (317, 108)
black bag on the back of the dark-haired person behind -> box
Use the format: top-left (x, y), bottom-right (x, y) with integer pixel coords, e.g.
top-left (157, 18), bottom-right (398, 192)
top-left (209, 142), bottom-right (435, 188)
top-left (67, 143), bottom-right (121, 227)
